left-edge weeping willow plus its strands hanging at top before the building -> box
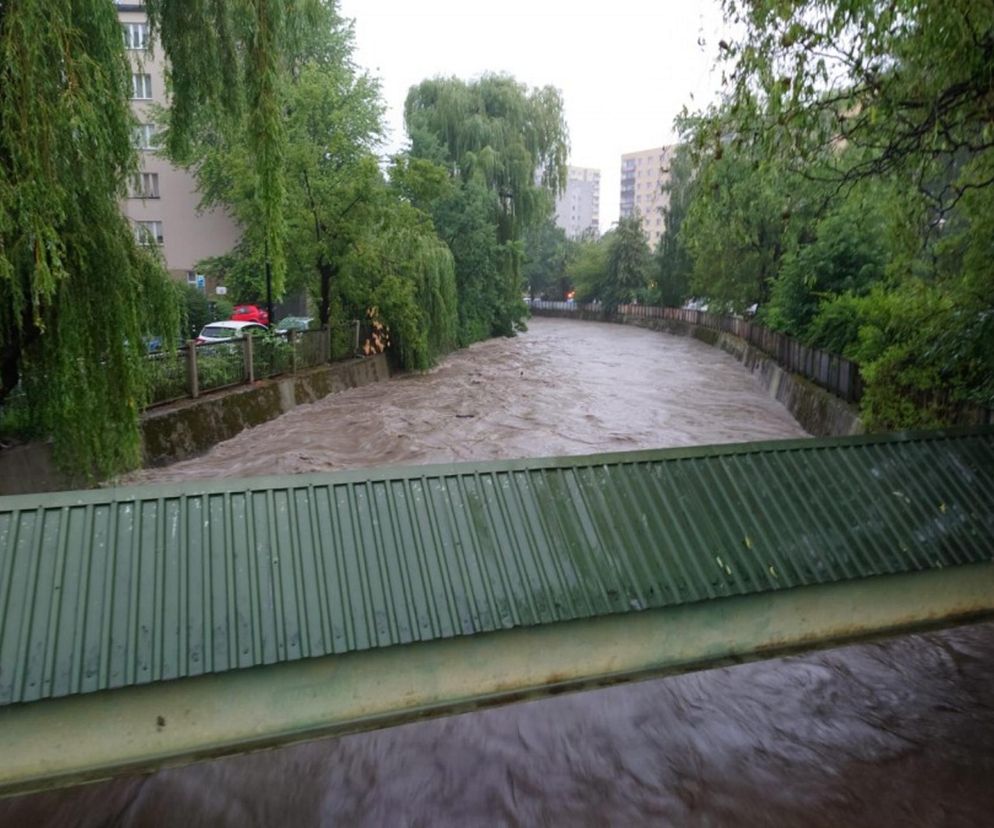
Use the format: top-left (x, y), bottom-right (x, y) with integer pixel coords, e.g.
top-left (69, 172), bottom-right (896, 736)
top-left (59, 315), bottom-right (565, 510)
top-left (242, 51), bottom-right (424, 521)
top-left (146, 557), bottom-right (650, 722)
top-left (0, 0), bottom-right (315, 476)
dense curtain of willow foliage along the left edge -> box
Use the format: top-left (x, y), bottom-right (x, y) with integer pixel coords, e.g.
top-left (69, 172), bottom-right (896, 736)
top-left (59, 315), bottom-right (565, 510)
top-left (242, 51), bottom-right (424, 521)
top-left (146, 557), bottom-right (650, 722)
top-left (0, 0), bottom-right (178, 476)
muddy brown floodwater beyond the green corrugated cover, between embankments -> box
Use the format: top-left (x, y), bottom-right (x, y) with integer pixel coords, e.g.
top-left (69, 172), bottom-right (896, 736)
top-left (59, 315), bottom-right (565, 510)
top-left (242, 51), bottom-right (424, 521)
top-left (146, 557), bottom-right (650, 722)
top-left (124, 319), bottom-right (805, 481)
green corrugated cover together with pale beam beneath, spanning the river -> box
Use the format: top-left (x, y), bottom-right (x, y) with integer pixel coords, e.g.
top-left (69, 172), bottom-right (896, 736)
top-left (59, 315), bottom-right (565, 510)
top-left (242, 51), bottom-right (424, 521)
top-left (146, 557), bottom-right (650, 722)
top-left (0, 427), bottom-right (994, 793)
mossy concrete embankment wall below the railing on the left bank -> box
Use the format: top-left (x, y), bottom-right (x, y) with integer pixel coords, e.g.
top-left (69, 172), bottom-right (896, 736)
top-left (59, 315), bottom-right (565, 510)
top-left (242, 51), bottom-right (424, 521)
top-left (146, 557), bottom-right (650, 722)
top-left (0, 354), bottom-right (390, 495)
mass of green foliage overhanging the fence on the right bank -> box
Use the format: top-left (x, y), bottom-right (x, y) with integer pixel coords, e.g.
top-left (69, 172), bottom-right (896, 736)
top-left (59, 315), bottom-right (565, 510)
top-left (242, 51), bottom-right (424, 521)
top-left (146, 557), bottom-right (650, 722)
top-left (670, 0), bottom-right (994, 428)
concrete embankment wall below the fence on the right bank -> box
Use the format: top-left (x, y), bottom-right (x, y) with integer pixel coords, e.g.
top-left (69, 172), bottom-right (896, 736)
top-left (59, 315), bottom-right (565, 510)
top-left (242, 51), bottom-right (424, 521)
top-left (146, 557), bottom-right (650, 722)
top-left (533, 309), bottom-right (863, 437)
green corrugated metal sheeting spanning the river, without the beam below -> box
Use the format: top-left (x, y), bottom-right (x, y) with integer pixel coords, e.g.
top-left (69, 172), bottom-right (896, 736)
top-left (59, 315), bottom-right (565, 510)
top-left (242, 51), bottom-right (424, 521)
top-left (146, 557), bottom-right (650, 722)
top-left (0, 428), bottom-right (994, 705)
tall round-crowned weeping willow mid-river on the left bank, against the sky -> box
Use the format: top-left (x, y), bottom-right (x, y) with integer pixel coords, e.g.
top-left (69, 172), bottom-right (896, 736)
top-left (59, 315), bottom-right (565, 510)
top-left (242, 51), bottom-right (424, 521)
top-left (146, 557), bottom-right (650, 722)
top-left (404, 75), bottom-right (569, 342)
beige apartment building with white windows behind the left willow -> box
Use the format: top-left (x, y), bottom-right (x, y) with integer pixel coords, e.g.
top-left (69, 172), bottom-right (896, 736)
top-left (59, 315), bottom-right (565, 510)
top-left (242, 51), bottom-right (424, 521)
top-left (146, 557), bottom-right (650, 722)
top-left (116, 2), bottom-right (241, 289)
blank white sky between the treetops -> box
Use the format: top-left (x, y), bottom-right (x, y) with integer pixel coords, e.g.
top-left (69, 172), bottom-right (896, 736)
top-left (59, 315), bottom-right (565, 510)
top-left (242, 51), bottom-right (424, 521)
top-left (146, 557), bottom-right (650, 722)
top-left (340, 0), bottom-right (723, 230)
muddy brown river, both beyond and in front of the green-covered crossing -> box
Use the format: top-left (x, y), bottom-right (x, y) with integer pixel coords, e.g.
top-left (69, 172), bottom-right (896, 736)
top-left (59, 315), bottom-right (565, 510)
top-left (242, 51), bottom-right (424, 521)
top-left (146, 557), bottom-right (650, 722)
top-left (0, 320), bottom-right (994, 828)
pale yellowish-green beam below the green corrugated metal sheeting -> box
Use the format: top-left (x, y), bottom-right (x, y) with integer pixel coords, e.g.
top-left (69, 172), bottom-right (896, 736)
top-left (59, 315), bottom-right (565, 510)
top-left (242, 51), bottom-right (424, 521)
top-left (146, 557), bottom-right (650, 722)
top-left (0, 563), bottom-right (994, 795)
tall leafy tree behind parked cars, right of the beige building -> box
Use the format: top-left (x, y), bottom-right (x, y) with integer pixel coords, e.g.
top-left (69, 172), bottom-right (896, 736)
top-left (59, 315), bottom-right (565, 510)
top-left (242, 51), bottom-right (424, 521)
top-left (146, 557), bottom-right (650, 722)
top-left (188, 4), bottom-right (382, 324)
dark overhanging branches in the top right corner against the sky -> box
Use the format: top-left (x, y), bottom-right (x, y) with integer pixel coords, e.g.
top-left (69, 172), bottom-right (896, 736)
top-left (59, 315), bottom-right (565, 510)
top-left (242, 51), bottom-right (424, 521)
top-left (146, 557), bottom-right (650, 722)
top-left (722, 0), bottom-right (994, 212)
